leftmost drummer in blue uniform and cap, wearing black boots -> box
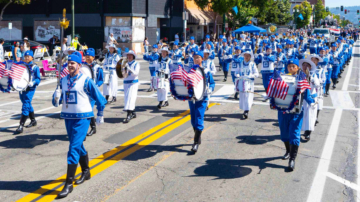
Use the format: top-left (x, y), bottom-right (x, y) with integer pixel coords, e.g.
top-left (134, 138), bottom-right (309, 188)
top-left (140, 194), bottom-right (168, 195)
top-left (16, 50), bottom-right (41, 134)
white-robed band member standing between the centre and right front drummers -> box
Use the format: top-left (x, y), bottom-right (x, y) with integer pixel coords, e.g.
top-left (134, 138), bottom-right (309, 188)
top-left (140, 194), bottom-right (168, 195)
top-left (236, 49), bottom-right (259, 119)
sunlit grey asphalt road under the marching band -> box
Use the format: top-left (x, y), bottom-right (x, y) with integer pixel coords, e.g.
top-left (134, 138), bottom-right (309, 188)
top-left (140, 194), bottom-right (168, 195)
top-left (0, 41), bottom-right (360, 202)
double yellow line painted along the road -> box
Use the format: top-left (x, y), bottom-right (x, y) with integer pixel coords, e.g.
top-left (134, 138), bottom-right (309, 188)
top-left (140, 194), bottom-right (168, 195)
top-left (18, 103), bottom-right (216, 202)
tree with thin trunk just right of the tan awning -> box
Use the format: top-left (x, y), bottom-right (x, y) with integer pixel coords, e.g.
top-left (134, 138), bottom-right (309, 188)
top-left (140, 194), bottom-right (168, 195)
top-left (194, 0), bottom-right (239, 34)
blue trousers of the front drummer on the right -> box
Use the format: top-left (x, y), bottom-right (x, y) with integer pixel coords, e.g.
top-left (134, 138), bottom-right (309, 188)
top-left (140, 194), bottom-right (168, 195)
top-left (278, 111), bottom-right (304, 146)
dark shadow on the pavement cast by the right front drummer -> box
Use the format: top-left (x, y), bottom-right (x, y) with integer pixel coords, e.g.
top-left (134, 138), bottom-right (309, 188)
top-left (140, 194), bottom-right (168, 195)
top-left (189, 157), bottom-right (287, 180)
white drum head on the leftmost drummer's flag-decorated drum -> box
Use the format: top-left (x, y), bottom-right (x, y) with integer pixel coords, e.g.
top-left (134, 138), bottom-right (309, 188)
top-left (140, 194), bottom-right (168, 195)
top-left (11, 63), bottom-right (31, 91)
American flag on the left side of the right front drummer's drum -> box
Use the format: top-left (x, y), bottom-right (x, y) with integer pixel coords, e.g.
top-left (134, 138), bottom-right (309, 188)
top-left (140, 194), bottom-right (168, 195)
top-left (266, 70), bottom-right (289, 100)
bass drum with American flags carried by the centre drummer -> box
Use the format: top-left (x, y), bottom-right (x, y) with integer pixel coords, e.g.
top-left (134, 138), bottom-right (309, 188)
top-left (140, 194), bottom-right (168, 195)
top-left (170, 65), bottom-right (206, 101)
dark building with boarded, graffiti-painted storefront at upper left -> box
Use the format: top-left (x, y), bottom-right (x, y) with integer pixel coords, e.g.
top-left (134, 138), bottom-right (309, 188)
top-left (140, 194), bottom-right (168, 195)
top-left (0, 0), bottom-right (184, 52)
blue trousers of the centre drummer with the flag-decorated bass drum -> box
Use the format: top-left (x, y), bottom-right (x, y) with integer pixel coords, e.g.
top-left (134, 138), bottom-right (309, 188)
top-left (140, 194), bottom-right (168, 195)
top-left (189, 99), bottom-right (207, 131)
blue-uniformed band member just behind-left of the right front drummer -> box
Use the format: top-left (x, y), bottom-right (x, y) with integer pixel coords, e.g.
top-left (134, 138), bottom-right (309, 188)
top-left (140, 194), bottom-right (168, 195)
top-left (255, 46), bottom-right (275, 97)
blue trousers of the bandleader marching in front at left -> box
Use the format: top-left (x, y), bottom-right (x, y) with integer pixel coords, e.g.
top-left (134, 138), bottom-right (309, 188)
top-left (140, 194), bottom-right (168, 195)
top-left (65, 118), bottom-right (91, 164)
